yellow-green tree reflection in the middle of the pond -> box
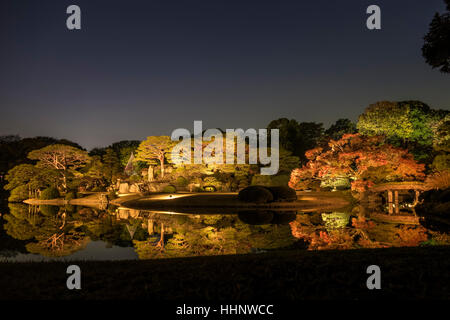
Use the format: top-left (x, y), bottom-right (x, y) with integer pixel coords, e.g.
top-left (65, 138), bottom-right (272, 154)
top-left (134, 214), bottom-right (296, 259)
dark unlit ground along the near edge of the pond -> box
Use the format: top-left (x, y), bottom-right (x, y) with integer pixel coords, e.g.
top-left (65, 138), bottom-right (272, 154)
top-left (0, 247), bottom-right (450, 303)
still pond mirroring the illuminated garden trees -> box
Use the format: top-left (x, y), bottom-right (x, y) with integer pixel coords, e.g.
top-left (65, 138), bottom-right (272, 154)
top-left (0, 203), bottom-right (450, 262)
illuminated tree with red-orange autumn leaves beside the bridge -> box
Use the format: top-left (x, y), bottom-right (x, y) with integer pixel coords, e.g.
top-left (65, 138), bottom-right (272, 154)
top-left (289, 134), bottom-right (425, 191)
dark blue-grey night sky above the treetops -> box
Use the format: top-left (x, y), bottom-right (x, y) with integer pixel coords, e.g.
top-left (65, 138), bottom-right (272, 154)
top-left (0, 0), bottom-right (450, 149)
